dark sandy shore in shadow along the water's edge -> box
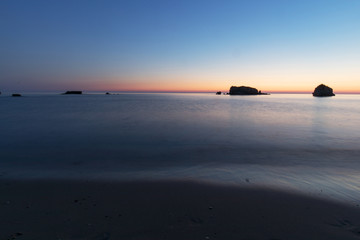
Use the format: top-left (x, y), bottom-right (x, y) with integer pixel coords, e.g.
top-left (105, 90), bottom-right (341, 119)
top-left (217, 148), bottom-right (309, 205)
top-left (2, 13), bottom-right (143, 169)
top-left (0, 180), bottom-right (360, 240)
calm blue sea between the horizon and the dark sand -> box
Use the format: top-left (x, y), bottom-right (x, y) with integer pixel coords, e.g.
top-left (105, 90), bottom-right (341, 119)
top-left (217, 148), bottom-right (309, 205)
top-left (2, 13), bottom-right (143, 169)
top-left (0, 94), bottom-right (360, 203)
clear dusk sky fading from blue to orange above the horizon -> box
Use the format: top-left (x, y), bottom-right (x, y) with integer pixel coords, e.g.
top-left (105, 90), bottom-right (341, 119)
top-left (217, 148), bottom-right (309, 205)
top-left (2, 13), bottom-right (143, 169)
top-left (0, 0), bottom-right (360, 93)
